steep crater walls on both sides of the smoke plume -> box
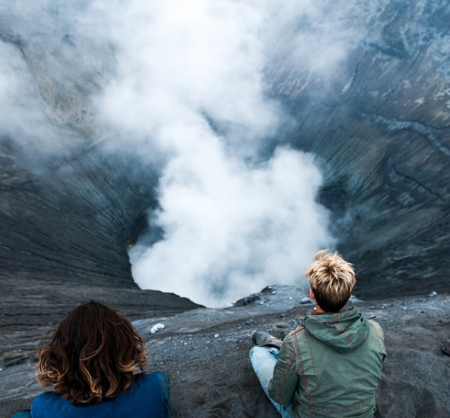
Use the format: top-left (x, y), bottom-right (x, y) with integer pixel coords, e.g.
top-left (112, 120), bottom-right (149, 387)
top-left (0, 1), bottom-right (450, 306)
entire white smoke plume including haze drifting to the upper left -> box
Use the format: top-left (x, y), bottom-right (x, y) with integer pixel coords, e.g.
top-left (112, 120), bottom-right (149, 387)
top-left (0, 0), bottom-right (394, 306)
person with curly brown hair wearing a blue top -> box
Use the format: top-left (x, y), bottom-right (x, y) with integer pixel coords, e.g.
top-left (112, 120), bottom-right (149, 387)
top-left (13, 301), bottom-right (170, 418)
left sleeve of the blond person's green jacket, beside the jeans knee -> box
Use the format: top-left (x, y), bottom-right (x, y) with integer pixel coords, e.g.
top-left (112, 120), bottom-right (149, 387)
top-left (269, 334), bottom-right (298, 405)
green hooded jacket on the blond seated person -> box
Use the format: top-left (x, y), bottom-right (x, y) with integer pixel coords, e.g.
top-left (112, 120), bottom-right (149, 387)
top-left (269, 308), bottom-right (386, 418)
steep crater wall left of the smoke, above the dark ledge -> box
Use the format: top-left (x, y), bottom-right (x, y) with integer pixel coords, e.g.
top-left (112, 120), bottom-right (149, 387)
top-left (0, 2), bottom-right (142, 287)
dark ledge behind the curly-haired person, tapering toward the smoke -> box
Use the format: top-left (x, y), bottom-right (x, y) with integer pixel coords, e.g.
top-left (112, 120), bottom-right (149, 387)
top-left (0, 277), bottom-right (200, 368)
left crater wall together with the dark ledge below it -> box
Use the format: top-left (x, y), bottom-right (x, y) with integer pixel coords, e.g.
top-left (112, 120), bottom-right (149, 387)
top-left (0, 2), bottom-right (199, 368)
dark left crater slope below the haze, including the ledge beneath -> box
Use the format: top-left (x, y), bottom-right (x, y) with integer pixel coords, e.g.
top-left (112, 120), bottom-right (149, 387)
top-left (0, 141), bottom-right (206, 367)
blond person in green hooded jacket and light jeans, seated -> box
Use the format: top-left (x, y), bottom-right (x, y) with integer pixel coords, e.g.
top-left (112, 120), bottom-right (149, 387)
top-left (250, 250), bottom-right (386, 418)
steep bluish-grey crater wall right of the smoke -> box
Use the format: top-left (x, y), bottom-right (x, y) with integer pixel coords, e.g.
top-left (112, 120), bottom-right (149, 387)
top-left (268, 1), bottom-right (450, 297)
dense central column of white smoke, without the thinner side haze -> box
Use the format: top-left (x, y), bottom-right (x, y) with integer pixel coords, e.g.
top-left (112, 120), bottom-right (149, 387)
top-left (93, 0), bottom-right (342, 306)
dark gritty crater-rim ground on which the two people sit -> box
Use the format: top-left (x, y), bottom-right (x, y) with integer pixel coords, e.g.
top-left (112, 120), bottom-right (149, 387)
top-left (0, 286), bottom-right (450, 418)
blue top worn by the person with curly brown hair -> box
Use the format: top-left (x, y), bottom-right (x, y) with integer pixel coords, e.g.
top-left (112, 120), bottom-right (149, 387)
top-left (31, 372), bottom-right (170, 418)
